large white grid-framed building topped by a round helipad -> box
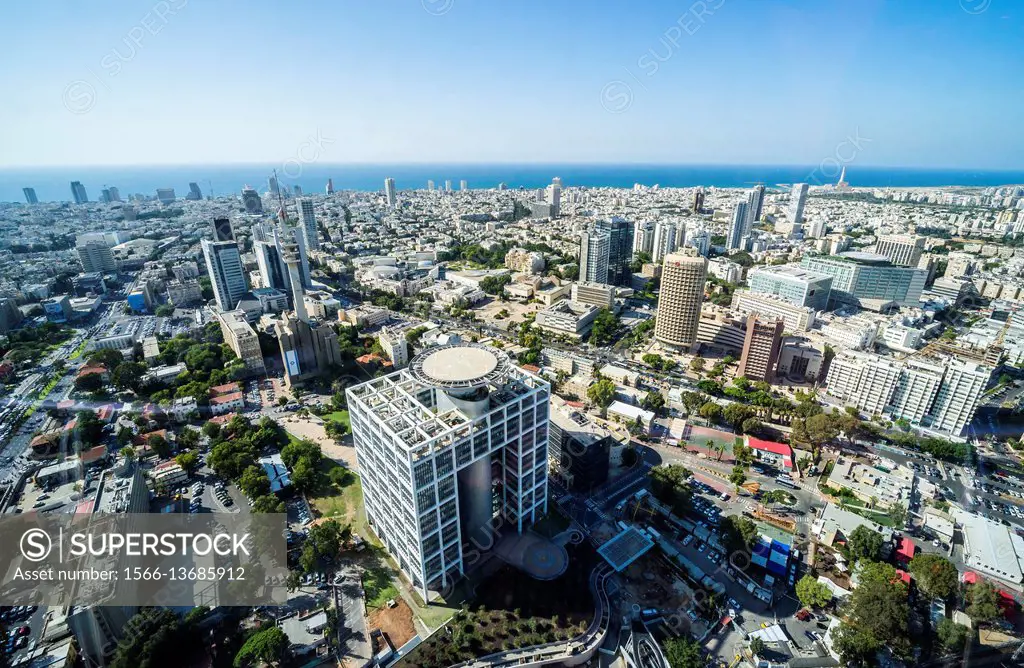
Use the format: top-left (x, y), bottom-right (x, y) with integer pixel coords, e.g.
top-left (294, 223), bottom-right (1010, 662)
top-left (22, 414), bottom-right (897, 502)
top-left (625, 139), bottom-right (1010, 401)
top-left (347, 344), bottom-right (550, 601)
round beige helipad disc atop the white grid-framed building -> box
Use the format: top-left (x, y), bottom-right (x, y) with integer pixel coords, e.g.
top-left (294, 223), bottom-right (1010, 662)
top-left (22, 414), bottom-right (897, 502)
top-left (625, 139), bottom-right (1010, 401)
top-left (409, 343), bottom-right (512, 389)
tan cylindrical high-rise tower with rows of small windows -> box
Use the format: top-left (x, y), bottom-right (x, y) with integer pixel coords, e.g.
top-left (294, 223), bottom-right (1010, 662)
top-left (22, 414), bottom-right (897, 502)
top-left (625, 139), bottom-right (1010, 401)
top-left (654, 248), bottom-right (708, 349)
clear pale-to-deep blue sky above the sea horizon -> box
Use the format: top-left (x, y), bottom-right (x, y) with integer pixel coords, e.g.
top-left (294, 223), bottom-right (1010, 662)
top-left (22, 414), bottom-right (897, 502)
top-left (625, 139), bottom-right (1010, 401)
top-left (0, 0), bottom-right (1024, 169)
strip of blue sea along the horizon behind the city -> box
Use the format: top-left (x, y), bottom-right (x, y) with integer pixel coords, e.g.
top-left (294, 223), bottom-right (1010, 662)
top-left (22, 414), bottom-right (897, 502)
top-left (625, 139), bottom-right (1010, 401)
top-left (0, 160), bottom-right (1024, 202)
